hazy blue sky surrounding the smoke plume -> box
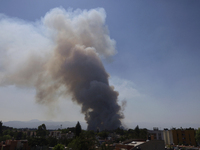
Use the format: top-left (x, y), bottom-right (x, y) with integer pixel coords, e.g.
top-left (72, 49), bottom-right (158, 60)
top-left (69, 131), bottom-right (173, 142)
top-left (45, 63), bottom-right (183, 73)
top-left (0, 0), bottom-right (200, 129)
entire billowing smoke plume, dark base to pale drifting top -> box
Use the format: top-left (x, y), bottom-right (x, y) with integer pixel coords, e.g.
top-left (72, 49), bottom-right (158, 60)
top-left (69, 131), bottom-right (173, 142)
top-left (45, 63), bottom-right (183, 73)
top-left (0, 8), bottom-right (123, 130)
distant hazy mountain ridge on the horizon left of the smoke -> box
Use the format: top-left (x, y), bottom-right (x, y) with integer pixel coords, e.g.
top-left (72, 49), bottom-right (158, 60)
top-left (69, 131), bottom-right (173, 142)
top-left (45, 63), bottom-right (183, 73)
top-left (3, 119), bottom-right (87, 130)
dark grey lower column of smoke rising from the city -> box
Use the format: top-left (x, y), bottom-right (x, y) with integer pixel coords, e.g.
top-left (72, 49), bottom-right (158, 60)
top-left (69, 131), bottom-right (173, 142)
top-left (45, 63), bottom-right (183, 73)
top-left (39, 43), bottom-right (123, 131)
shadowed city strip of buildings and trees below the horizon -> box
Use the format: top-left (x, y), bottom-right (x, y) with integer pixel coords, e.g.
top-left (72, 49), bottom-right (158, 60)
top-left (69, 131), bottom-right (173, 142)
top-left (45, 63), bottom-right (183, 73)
top-left (0, 122), bottom-right (200, 150)
